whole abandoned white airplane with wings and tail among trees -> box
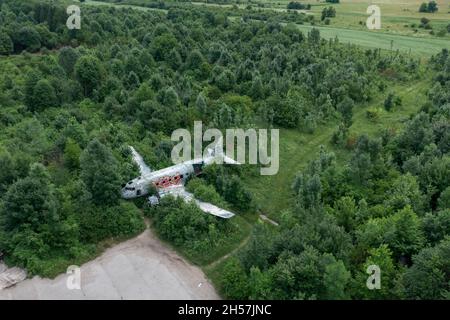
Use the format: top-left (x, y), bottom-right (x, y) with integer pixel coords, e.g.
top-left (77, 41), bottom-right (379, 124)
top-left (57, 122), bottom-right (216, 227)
top-left (122, 139), bottom-right (239, 219)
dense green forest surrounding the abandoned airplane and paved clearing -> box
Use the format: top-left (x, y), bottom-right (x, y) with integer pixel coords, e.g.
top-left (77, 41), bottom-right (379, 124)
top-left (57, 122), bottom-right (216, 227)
top-left (0, 0), bottom-right (450, 300)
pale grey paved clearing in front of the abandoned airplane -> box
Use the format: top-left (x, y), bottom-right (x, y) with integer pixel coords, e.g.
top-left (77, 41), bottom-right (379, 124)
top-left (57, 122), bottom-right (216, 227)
top-left (0, 229), bottom-right (220, 300)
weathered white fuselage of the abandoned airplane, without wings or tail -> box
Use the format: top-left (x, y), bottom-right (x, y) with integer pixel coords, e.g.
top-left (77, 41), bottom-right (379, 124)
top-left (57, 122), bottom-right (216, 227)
top-left (122, 159), bottom-right (205, 199)
